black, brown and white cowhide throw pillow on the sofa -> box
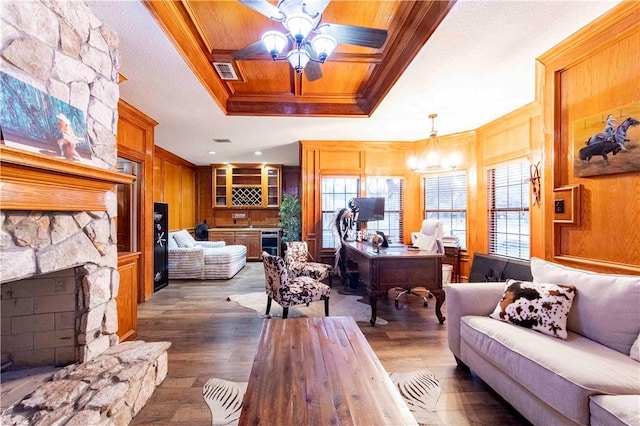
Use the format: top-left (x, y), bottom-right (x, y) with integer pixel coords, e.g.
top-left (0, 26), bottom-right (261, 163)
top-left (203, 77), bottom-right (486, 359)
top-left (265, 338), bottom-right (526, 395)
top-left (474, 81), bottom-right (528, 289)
top-left (489, 280), bottom-right (576, 339)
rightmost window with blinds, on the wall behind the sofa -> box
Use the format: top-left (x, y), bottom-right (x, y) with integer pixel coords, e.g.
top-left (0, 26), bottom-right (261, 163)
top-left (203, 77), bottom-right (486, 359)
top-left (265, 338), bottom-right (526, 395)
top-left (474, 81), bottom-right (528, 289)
top-left (487, 160), bottom-right (530, 259)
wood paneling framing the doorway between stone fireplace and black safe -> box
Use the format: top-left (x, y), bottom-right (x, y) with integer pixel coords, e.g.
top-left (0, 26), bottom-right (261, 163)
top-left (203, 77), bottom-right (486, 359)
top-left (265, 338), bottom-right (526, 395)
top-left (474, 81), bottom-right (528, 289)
top-left (116, 100), bottom-right (158, 302)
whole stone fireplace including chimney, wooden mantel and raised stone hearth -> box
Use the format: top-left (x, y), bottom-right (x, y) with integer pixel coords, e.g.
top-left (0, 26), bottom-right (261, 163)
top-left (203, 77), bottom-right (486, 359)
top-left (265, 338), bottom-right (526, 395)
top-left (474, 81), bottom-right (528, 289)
top-left (0, 0), bottom-right (170, 425)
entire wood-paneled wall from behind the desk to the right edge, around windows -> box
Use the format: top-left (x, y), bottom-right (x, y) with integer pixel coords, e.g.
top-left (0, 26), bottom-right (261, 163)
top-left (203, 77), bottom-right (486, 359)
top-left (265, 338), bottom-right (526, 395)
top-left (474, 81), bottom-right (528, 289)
top-left (301, 2), bottom-right (640, 277)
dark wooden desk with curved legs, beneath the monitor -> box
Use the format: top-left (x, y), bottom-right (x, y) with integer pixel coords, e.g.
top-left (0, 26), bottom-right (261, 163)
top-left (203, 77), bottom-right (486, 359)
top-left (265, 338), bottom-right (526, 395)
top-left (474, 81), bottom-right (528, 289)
top-left (342, 241), bottom-right (445, 325)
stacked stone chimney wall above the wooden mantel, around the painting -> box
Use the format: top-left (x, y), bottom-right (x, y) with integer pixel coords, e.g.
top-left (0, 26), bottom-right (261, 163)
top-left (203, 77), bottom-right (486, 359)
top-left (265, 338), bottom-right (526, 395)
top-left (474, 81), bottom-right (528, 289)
top-left (0, 0), bottom-right (120, 170)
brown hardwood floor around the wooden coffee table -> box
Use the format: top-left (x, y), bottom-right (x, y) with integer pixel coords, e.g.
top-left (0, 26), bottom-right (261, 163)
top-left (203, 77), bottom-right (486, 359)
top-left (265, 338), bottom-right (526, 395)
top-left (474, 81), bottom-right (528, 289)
top-left (131, 262), bottom-right (528, 426)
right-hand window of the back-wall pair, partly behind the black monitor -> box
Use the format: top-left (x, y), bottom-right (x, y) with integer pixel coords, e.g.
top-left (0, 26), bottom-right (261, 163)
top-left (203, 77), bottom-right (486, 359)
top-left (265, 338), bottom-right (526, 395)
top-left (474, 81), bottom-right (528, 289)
top-left (366, 177), bottom-right (404, 242)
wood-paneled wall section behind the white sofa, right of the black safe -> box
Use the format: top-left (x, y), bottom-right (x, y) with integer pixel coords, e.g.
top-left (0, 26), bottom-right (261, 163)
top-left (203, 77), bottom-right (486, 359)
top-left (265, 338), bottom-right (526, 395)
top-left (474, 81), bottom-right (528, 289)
top-left (153, 146), bottom-right (198, 231)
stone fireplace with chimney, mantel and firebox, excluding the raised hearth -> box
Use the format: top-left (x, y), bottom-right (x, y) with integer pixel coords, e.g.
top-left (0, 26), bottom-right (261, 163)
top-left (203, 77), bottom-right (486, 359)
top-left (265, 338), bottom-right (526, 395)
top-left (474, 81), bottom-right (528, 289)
top-left (0, 0), bottom-right (133, 366)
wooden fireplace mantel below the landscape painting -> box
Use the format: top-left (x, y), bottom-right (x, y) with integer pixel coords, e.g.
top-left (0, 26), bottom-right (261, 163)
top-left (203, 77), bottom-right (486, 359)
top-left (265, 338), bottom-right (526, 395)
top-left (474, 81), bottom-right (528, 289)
top-left (0, 145), bottom-right (135, 211)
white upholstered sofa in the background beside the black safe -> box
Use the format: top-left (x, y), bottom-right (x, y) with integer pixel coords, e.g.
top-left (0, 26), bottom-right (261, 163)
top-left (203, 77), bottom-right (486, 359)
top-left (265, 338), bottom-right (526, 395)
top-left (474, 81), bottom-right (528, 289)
top-left (167, 229), bottom-right (247, 280)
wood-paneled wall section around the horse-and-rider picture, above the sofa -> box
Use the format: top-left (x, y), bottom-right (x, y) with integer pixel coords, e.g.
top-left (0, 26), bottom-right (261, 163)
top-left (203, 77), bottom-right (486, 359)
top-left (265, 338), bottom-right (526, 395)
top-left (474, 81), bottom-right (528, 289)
top-left (538, 2), bottom-right (640, 274)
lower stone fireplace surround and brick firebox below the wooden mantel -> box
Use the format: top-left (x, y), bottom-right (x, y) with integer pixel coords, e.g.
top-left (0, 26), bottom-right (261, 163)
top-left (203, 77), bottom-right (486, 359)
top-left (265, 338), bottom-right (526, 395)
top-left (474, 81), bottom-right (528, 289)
top-left (0, 208), bottom-right (118, 368)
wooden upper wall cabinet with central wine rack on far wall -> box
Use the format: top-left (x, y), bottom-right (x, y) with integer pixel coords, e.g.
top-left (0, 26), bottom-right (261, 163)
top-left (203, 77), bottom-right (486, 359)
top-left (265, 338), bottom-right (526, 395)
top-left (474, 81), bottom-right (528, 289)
top-left (212, 164), bottom-right (282, 208)
